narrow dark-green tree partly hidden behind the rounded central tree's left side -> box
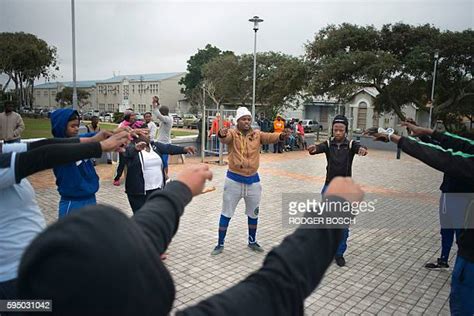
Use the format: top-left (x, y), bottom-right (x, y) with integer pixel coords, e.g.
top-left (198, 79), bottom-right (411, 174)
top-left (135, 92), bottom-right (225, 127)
top-left (179, 44), bottom-right (233, 105)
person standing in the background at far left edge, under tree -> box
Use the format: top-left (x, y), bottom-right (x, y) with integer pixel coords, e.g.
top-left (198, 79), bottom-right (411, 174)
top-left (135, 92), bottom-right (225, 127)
top-left (0, 101), bottom-right (25, 144)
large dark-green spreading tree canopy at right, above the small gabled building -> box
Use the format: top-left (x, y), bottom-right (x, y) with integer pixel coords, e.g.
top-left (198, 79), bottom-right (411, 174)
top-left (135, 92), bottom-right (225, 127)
top-left (306, 23), bottom-right (474, 119)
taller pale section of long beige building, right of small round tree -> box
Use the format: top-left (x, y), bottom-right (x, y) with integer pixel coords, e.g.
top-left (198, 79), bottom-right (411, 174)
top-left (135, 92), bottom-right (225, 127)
top-left (97, 72), bottom-right (185, 113)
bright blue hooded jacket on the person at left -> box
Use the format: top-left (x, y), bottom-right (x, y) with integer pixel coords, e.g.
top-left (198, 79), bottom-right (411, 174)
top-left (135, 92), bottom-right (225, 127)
top-left (51, 109), bottom-right (99, 200)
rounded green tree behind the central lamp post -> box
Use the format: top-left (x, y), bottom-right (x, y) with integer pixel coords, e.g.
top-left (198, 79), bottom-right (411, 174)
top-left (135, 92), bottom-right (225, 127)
top-left (203, 52), bottom-right (306, 115)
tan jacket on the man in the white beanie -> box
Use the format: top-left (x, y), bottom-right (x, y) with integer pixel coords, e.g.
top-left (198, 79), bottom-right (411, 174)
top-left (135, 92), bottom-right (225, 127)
top-left (219, 129), bottom-right (280, 177)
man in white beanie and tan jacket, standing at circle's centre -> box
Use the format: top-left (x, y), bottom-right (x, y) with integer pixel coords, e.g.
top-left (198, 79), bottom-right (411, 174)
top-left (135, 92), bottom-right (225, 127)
top-left (211, 107), bottom-right (288, 255)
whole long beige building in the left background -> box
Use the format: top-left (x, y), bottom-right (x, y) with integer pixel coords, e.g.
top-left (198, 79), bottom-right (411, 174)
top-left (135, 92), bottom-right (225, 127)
top-left (34, 72), bottom-right (188, 113)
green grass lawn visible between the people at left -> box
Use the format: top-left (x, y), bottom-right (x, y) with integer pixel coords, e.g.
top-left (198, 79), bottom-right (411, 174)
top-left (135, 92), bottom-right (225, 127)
top-left (21, 117), bottom-right (197, 138)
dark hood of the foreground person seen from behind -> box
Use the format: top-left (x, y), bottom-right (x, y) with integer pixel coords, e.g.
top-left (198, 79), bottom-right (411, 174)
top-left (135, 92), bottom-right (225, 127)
top-left (18, 205), bottom-right (175, 315)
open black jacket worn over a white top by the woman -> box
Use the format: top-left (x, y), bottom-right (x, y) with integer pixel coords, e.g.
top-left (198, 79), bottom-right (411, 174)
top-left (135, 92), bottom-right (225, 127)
top-left (123, 141), bottom-right (186, 195)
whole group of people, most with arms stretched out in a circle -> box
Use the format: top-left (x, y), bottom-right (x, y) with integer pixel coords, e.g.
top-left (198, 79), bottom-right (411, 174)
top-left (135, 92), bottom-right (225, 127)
top-left (0, 97), bottom-right (474, 315)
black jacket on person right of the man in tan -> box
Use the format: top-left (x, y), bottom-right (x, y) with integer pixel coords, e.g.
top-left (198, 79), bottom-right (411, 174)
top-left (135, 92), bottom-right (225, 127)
top-left (316, 138), bottom-right (362, 184)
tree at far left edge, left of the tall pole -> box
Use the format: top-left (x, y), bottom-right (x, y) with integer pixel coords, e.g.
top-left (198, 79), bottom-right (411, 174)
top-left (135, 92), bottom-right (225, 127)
top-left (0, 32), bottom-right (59, 107)
